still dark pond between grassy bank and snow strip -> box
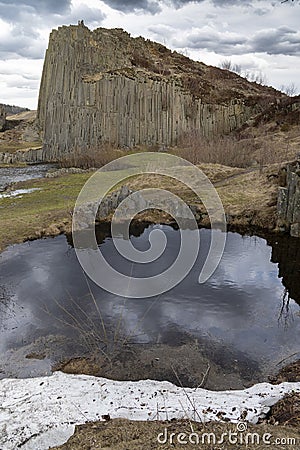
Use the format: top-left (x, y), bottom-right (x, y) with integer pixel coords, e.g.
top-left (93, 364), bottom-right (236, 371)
top-left (0, 225), bottom-right (300, 388)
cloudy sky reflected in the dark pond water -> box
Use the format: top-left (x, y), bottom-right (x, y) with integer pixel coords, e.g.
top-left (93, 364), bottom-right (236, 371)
top-left (0, 227), bottom-right (300, 370)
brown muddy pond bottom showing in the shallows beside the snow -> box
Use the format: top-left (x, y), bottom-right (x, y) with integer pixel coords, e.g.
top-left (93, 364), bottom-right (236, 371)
top-left (53, 340), bottom-right (267, 391)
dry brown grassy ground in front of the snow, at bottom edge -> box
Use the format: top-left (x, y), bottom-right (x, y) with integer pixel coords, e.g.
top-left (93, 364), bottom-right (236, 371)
top-left (52, 411), bottom-right (300, 450)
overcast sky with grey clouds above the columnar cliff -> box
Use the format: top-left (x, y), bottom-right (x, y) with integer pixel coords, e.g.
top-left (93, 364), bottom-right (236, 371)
top-left (0, 0), bottom-right (300, 109)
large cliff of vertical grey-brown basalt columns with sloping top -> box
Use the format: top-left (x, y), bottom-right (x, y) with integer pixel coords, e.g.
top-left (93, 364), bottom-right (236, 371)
top-left (38, 24), bottom-right (280, 160)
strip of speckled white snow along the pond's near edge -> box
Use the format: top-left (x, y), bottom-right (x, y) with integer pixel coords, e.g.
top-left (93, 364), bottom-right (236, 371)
top-left (0, 372), bottom-right (300, 450)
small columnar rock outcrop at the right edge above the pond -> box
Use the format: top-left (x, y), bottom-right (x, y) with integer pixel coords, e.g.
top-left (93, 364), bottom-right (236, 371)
top-left (277, 161), bottom-right (300, 237)
